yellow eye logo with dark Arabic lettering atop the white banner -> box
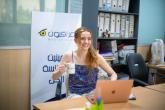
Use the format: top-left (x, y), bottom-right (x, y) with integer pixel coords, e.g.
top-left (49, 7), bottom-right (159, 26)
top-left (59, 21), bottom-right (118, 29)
top-left (38, 29), bottom-right (74, 38)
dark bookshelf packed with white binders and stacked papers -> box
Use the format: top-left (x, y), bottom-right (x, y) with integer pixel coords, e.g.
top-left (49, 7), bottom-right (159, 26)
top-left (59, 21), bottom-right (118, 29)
top-left (96, 0), bottom-right (140, 65)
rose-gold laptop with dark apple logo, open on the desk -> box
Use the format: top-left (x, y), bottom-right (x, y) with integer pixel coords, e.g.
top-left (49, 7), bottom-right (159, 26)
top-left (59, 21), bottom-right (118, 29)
top-left (87, 80), bottom-right (133, 104)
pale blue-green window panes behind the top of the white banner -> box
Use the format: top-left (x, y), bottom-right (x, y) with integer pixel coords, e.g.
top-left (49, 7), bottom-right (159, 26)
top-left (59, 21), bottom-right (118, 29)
top-left (0, 0), bottom-right (83, 46)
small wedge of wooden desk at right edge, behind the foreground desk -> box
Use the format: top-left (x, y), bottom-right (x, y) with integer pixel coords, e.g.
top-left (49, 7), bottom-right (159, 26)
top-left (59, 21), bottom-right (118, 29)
top-left (147, 83), bottom-right (165, 93)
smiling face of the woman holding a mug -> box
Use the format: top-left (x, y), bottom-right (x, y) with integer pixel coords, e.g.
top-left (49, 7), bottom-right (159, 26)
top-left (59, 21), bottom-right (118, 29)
top-left (77, 31), bottom-right (92, 50)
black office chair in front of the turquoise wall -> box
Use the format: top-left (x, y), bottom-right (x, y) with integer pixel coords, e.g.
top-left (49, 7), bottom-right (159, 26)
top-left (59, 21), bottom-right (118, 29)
top-left (126, 53), bottom-right (149, 86)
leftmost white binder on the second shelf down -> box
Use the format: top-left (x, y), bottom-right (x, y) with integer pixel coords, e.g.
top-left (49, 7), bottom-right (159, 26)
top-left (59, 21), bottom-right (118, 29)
top-left (99, 13), bottom-right (104, 37)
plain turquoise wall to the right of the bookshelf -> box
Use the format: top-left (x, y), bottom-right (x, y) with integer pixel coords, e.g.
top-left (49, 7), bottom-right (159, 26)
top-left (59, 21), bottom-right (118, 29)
top-left (138, 0), bottom-right (165, 45)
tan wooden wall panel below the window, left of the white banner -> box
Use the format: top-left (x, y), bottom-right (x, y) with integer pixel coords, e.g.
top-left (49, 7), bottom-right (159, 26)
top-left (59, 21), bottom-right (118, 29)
top-left (0, 49), bottom-right (30, 110)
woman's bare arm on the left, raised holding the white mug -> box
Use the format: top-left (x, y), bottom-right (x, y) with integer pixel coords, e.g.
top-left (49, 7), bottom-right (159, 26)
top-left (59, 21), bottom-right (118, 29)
top-left (52, 53), bottom-right (70, 80)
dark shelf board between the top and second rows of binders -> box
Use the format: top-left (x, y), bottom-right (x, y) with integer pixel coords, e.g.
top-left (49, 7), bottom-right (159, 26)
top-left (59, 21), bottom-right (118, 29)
top-left (99, 9), bottom-right (139, 15)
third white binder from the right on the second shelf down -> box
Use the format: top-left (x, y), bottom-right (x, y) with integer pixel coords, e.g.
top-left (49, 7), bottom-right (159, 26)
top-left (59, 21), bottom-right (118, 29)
top-left (120, 15), bottom-right (126, 38)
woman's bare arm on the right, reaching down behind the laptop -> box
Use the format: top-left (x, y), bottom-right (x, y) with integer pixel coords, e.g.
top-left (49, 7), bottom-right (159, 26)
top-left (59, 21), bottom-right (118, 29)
top-left (98, 54), bottom-right (117, 80)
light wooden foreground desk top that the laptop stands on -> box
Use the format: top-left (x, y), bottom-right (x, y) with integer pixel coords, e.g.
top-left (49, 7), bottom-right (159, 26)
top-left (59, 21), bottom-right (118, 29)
top-left (34, 87), bottom-right (165, 110)
